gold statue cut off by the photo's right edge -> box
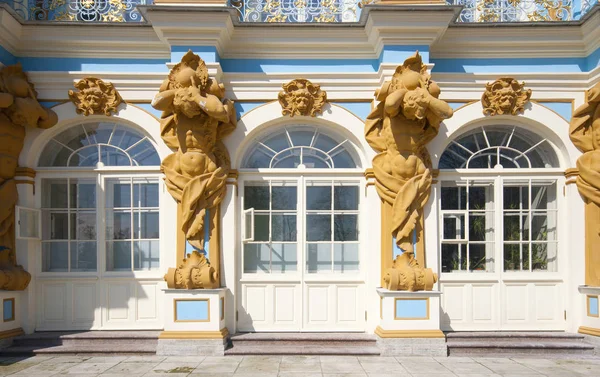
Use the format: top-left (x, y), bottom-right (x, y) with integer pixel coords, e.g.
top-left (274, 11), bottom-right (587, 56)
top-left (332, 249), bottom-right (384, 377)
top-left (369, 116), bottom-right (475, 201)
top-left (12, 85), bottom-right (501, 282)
top-left (569, 83), bottom-right (600, 287)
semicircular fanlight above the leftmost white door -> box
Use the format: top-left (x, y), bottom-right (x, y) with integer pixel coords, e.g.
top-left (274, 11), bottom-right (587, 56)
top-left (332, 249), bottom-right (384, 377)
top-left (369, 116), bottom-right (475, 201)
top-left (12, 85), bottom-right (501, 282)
top-left (39, 122), bottom-right (160, 167)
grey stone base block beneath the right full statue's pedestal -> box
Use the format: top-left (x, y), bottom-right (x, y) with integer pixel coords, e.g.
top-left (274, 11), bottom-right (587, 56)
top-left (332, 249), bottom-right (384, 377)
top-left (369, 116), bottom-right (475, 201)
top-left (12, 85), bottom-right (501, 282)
top-left (377, 338), bottom-right (448, 356)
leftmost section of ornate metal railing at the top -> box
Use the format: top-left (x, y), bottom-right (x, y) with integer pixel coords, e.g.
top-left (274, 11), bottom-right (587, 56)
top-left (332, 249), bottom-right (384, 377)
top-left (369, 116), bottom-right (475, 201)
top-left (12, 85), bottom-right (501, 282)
top-left (0, 0), bottom-right (153, 22)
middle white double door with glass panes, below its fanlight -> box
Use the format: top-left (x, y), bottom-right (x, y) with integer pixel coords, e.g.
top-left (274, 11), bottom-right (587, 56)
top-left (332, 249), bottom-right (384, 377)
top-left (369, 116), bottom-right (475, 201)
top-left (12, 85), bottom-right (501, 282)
top-left (238, 174), bottom-right (365, 331)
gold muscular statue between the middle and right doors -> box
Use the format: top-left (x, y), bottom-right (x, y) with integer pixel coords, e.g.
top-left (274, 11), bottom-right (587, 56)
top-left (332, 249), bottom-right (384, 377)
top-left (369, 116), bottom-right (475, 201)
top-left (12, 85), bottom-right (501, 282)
top-left (365, 52), bottom-right (452, 290)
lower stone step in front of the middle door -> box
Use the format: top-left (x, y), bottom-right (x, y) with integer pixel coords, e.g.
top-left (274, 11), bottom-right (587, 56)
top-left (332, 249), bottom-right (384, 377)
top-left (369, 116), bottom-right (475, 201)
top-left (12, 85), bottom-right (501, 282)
top-left (225, 343), bottom-right (380, 356)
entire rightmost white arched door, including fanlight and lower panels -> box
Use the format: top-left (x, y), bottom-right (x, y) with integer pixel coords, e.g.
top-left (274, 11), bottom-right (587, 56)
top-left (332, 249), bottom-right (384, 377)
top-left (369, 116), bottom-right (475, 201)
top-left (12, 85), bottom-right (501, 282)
top-left (436, 127), bottom-right (567, 331)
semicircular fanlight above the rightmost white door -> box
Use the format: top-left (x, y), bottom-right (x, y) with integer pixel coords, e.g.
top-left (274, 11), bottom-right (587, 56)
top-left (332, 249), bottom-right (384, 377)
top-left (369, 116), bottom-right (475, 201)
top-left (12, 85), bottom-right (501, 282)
top-left (439, 126), bottom-right (558, 169)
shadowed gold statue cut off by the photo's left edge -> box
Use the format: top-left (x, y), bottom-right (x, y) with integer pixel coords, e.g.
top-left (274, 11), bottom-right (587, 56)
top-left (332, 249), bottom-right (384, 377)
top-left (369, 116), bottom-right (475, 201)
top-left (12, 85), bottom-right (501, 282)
top-left (0, 64), bottom-right (58, 291)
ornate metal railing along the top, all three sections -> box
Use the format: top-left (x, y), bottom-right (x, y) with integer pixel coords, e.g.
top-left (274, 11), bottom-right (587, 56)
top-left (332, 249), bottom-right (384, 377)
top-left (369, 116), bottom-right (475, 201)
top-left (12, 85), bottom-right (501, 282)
top-left (0, 0), bottom-right (599, 23)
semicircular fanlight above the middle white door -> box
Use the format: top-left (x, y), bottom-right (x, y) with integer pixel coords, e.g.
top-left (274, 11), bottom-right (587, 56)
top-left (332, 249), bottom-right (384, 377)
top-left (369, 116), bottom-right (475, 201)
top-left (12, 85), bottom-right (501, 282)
top-left (242, 125), bottom-right (358, 169)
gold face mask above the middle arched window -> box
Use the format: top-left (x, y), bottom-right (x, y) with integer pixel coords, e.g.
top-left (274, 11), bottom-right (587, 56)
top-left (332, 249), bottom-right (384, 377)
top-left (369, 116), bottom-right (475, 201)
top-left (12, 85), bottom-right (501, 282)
top-left (279, 79), bottom-right (327, 117)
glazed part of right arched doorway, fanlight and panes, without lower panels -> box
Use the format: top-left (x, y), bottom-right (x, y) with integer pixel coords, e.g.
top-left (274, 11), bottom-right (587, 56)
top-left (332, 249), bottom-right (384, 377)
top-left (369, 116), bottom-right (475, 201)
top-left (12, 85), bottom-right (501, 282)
top-left (439, 126), bottom-right (562, 273)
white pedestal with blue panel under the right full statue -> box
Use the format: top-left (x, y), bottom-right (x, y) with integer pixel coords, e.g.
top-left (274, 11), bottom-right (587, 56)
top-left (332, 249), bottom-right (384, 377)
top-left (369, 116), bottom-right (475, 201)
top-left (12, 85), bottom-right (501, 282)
top-left (375, 288), bottom-right (448, 356)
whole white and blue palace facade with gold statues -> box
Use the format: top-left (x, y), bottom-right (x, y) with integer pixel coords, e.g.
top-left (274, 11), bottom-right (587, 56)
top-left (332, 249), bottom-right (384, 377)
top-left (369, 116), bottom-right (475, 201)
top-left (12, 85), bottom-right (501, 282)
top-left (0, 0), bottom-right (600, 353)
